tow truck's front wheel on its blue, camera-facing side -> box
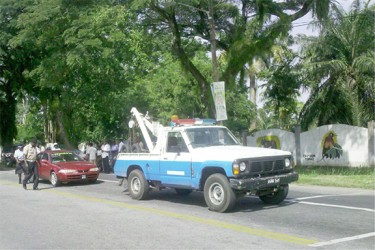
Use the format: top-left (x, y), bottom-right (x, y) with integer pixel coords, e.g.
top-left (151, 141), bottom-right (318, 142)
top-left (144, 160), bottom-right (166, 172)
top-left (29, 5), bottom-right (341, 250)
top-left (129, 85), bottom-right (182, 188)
top-left (203, 174), bottom-right (236, 213)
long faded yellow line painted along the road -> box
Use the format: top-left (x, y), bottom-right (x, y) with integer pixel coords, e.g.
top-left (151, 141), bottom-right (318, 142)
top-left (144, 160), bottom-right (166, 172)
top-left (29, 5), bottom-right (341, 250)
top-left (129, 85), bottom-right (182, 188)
top-left (0, 181), bottom-right (318, 246)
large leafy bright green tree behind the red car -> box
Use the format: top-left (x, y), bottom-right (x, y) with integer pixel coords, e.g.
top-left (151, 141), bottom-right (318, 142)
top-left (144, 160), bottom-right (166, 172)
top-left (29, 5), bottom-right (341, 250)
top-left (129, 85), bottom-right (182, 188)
top-left (10, 0), bottom-right (156, 147)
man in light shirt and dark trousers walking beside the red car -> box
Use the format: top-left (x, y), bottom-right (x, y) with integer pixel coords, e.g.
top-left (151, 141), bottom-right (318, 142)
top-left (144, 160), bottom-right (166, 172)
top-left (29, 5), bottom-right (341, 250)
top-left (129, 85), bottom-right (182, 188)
top-left (23, 139), bottom-right (39, 190)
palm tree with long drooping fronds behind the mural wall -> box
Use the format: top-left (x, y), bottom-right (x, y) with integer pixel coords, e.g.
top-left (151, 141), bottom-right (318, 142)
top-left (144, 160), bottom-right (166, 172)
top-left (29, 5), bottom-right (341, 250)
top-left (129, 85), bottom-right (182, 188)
top-left (300, 0), bottom-right (375, 130)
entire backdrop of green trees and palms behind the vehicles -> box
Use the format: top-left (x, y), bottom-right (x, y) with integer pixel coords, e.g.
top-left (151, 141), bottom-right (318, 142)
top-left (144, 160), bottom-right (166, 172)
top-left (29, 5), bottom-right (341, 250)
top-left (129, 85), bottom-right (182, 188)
top-left (0, 0), bottom-right (375, 147)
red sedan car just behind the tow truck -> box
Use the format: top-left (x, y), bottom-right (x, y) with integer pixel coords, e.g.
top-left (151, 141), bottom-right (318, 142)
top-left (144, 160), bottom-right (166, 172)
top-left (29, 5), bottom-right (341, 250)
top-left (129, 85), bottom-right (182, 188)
top-left (37, 150), bottom-right (99, 187)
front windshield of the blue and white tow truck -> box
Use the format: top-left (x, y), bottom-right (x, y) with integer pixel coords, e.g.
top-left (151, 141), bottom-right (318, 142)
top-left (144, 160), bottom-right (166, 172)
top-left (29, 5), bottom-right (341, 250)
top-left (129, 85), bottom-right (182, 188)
top-left (186, 127), bottom-right (239, 148)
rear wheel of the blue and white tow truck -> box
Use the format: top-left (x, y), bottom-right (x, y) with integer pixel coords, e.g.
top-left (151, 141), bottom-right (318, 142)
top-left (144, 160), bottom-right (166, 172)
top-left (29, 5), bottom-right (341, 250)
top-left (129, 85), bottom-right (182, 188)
top-left (128, 169), bottom-right (149, 200)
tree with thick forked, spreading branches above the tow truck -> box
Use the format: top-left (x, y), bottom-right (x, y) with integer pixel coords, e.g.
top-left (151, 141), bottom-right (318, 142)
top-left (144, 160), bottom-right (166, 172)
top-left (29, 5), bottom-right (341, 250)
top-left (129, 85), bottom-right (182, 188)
top-left (132, 0), bottom-right (331, 115)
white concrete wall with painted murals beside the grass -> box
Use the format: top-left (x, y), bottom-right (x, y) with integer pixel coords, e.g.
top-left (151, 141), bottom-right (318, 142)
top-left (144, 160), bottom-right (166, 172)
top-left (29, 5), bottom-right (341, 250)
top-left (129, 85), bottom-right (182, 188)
top-left (247, 122), bottom-right (375, 167)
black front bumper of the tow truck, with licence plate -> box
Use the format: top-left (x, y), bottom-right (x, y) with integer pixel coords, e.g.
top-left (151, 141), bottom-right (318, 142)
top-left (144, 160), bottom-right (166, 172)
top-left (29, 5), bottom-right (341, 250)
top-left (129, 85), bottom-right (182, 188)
top-left (230, 172), bottom-right (298, 192)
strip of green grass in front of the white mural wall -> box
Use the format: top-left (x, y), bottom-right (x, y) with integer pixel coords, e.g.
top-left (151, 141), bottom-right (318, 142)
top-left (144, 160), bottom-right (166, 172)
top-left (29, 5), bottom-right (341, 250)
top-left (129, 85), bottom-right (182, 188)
top-left (296, 166), bottom-right (375, 189)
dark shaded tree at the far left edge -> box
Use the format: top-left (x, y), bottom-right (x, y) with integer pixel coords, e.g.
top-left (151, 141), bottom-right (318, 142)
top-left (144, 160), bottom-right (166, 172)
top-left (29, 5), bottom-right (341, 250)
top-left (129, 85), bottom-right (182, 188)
top-left (0, 0), bottom-right (31, 145)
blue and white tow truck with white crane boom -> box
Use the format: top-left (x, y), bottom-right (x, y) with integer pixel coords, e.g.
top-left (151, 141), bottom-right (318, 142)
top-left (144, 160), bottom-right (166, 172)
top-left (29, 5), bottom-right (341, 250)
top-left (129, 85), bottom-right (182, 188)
top-left (114, 108), bottom-right (298, 212)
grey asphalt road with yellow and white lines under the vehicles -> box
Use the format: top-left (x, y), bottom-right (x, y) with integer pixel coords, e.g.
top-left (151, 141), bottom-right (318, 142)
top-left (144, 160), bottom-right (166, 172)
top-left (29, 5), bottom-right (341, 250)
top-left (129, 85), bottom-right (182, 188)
top-left (0, 171), bottom-right (375, 249)
